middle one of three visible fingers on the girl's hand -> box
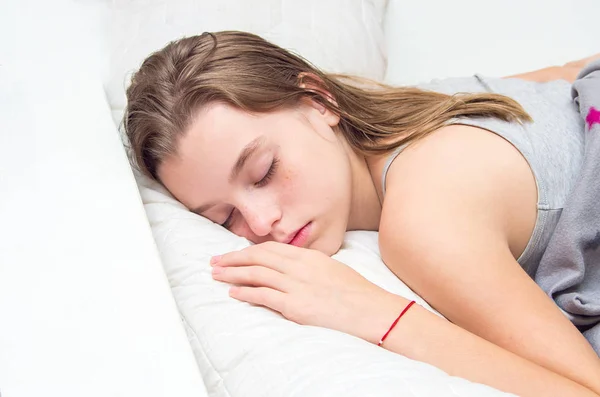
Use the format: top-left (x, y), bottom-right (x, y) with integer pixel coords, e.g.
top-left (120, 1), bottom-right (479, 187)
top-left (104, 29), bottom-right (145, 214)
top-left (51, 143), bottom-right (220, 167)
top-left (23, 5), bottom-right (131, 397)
top-left (212, 266), bottom-right (292, 292)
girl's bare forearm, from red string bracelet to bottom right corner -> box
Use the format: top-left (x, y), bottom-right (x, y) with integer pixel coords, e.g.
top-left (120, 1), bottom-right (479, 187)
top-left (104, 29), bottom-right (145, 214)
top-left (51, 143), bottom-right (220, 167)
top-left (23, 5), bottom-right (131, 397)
top-left (383, 297), bottom-right (598, 397)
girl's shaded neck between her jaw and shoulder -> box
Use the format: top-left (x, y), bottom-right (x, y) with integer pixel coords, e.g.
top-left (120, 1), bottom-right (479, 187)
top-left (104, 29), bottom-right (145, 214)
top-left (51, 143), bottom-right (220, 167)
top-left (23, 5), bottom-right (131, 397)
top-left (347, 150), bottom-right (381, 231)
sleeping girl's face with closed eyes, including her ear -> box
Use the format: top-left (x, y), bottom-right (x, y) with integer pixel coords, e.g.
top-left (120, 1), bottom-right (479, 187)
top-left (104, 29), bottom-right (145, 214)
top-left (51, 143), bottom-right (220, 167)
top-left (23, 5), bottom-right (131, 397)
top-left (158, 99), bottom-right (352, 255)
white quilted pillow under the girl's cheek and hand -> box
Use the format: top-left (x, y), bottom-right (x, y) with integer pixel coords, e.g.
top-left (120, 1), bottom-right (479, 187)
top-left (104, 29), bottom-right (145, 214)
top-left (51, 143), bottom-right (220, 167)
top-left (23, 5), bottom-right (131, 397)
top-left (138, 171), bottom-right (516, 397)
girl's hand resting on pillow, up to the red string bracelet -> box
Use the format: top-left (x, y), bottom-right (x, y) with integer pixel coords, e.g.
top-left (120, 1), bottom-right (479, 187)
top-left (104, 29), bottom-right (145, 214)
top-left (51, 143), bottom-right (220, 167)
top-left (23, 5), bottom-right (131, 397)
top-left (211, 241), bottom-right (408, 343)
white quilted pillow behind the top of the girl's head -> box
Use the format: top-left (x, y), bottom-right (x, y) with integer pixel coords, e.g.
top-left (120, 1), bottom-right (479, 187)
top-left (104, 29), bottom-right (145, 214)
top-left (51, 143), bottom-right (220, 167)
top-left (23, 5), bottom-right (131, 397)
top-left (106, 0), bottom-right (387, 121)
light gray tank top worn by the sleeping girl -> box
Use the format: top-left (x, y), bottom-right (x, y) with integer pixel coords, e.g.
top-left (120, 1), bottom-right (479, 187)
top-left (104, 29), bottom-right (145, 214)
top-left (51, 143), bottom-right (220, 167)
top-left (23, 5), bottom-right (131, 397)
top-left (381, 75), bottom-right (584, 278)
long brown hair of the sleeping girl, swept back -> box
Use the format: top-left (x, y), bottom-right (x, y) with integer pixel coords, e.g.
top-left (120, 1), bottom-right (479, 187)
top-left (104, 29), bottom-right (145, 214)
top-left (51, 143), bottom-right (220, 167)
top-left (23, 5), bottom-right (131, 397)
top-left (123, 31), bottom-right (530, 179)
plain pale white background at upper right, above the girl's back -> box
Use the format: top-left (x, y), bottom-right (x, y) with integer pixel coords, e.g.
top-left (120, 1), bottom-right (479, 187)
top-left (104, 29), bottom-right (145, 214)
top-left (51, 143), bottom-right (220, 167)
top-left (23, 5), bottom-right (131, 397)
top-left (384, 0), bottom-right (600, 85)
